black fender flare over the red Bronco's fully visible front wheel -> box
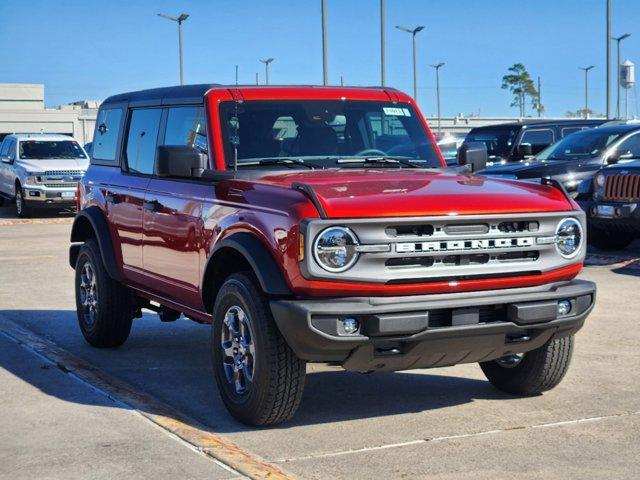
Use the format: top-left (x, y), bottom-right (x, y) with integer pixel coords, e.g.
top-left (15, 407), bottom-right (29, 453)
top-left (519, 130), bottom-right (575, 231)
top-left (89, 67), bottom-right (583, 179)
top-left (200, 232), bottom-right (293, 305)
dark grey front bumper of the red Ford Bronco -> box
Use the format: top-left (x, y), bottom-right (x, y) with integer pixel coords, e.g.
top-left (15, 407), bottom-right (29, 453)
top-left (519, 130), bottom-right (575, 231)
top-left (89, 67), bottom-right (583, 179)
top-left (270, 280), bottom-right (596, 371)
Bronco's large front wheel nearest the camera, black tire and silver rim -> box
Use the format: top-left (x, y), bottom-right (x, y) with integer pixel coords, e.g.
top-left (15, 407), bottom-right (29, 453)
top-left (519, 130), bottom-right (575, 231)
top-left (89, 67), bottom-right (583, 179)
top-left (211, 272), bottom-right (306, 426)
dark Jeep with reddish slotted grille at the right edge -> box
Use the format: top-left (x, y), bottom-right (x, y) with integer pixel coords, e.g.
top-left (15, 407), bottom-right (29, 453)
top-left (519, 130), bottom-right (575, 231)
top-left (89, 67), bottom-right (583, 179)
top-left (578, 162), bottom-right (640, 250)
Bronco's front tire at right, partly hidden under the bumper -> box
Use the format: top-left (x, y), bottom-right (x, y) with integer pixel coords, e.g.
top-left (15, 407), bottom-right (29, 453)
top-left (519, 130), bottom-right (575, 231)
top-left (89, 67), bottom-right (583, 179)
top-left (480, 335), bottom-right (573, 395)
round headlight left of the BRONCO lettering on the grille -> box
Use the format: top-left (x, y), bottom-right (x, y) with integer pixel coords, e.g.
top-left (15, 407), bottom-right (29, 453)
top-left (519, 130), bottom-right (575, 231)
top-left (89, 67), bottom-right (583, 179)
top-left (313, 227), bottom-right (358, 273)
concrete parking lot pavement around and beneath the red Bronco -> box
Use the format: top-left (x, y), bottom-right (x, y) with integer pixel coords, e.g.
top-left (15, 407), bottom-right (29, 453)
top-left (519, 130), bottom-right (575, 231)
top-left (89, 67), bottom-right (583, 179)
top-left (0, 208), bottom-right (640, 480)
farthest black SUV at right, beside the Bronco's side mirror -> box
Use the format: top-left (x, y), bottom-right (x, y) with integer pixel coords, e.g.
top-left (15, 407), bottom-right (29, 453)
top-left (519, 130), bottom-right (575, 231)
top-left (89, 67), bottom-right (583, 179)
top-left (465, 120), bottom-right (606, 163)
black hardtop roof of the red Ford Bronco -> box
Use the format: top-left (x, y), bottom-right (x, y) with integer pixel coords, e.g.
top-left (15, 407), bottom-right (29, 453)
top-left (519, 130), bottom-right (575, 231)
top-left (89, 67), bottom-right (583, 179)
top-left (102, 83), bottom-right (396, 105)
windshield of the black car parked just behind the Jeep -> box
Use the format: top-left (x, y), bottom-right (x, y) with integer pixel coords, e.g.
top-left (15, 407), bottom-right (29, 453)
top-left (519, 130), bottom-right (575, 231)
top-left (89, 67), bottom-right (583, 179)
top-left (536, 128), bottom-right (622, 160)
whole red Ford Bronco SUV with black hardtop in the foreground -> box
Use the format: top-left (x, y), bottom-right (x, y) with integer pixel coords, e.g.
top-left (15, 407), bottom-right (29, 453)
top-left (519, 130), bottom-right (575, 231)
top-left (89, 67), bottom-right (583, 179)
top-left (69, 85), bottom-right (596, 425)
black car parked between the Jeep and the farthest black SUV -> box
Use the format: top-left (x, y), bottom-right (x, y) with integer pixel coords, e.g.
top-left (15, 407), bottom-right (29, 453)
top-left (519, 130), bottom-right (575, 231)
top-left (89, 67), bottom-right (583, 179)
top-left (480, 123), bottom-right (640, 198)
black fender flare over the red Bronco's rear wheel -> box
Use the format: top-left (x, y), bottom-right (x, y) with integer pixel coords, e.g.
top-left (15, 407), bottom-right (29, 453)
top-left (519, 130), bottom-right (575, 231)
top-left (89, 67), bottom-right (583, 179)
top-left (69, 207), bottom-right (122, 282)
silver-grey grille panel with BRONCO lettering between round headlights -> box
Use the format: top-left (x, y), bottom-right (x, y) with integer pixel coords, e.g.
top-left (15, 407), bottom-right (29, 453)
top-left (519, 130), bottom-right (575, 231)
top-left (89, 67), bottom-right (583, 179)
top-left (303, 211), bottom-right (585, 285)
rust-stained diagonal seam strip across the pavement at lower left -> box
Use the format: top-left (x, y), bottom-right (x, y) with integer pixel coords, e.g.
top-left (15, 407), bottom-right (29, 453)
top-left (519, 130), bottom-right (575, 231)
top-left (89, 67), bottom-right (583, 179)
top-left (0, 314), bottom-right (295, 480)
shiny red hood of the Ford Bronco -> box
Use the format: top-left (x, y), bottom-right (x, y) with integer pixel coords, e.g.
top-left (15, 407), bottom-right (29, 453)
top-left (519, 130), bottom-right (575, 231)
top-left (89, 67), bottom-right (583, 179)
top-left (259, 169), bottom-right (573, 218)
